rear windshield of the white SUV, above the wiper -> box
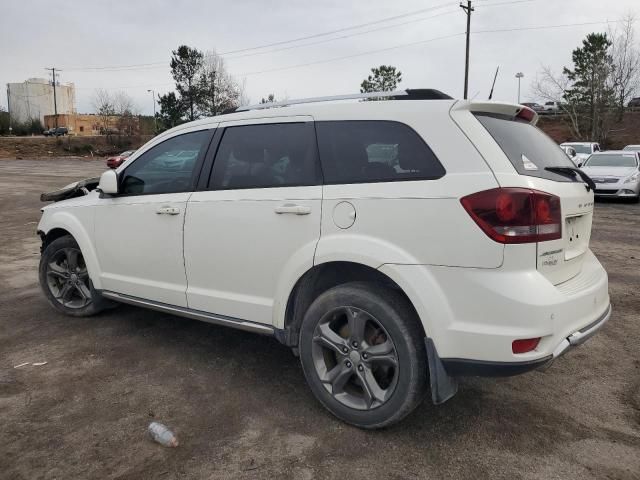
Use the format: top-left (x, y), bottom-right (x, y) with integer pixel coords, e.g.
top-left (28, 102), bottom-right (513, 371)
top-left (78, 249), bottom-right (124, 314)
top-left (476, 114), bottom-right (578, 182)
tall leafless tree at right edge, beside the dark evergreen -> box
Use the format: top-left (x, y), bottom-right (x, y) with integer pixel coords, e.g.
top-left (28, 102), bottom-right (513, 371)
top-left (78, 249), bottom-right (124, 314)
top-left (609, 13), bottom-right (640, 120)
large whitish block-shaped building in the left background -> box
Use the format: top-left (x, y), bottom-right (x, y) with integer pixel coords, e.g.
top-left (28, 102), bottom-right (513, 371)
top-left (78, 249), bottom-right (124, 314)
top-left (7, 78), bottom-right (76, 125)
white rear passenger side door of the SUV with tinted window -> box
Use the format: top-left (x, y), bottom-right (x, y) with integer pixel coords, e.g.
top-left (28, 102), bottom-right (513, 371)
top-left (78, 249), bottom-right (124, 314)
top-left (185, 117), bottom-right (322, 324)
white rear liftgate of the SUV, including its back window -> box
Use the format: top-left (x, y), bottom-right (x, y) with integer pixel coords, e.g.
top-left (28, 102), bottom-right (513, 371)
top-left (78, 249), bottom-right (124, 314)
top-left (456, 104), bottom-right (594, 284)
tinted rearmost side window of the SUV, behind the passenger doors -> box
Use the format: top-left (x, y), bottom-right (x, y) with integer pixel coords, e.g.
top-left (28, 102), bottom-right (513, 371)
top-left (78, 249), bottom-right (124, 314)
top-left (316, 120), bottom-right (445, 184)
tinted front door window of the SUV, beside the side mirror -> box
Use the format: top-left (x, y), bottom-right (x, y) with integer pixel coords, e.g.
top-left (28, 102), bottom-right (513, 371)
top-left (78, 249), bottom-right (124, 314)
top-left (120, 130), bottom-right (211, 195)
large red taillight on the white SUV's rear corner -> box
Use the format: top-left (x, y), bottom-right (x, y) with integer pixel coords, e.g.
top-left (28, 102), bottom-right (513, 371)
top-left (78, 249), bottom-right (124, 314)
top-left (460, 188), bottom-right (562, 243)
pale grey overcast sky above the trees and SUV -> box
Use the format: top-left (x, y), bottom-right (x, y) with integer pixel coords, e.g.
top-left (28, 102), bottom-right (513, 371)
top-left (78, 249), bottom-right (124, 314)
top-left (0, 0), bottom-right (640, 114)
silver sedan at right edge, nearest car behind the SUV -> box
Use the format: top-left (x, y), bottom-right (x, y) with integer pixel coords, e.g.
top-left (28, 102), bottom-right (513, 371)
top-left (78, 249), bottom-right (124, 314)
top-left (582, 150), bottom-right (640, 202)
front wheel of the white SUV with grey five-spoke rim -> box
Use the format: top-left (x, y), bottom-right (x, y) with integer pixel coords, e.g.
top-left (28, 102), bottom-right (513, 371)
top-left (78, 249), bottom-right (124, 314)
top-left (39, 235), bottom-right (112, 317)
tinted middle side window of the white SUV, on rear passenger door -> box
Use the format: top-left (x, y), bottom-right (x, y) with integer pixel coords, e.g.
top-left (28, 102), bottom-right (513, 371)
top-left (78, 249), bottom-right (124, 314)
top-left (210, 123), bottom-right (320, 190)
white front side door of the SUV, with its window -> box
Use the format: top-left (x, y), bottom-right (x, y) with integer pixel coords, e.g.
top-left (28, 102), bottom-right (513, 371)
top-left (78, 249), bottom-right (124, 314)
top-left (95, 130), bottom-right (212, 307)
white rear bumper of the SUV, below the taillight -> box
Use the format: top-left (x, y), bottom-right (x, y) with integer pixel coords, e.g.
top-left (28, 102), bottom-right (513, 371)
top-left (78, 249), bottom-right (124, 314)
top-left (381, 247), bottom-right (610, 364)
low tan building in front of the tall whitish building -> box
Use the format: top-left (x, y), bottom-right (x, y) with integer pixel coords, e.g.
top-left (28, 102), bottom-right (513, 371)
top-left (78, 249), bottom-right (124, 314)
top-left (44, 114), bottom-right (140, 136)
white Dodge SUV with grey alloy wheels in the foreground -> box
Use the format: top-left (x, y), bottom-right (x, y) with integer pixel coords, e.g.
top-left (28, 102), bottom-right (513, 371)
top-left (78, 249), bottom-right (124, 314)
top-left (38, 90), bottom-right (611, 428)
